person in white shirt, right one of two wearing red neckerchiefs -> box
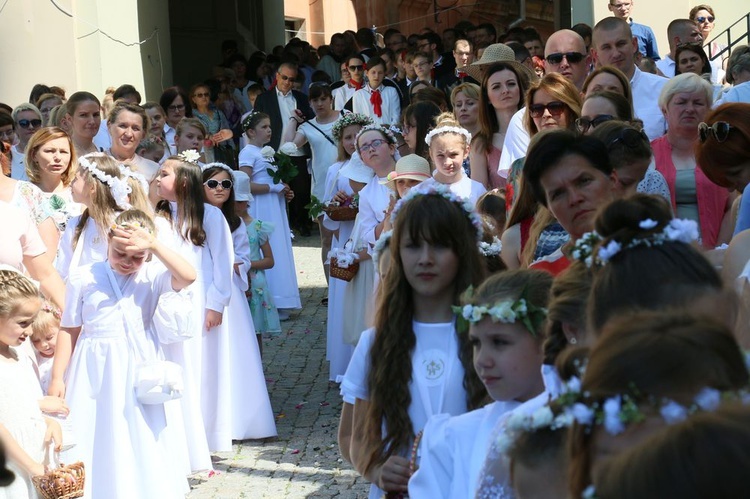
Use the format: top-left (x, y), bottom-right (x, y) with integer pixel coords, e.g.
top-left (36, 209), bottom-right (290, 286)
top-left (352, 56), bottom-right (401, 125)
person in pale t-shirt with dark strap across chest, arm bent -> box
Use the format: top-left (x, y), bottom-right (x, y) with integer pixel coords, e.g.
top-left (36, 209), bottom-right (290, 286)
top-left (281, 82), bottom-right (341, 281)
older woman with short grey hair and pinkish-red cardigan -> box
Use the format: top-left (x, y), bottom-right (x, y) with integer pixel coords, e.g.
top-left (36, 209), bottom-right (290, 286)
top-left (651, 73), bottom-right (732, 249)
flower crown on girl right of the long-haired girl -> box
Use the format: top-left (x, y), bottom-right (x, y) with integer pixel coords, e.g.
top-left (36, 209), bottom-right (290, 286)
top-left (452, 287), bottom-right (547, 338)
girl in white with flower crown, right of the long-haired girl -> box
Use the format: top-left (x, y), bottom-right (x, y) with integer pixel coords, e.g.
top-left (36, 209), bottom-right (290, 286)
top-left (409, 270), bottom-right (552, 499)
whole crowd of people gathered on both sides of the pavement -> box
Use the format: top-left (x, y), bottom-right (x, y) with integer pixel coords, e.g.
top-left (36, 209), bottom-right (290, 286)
top-left (0, 0), bottom-right (750, 498)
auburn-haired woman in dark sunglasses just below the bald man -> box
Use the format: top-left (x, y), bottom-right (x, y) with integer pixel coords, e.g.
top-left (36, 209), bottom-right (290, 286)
top-left (500, 73), bottom-right (582, 269)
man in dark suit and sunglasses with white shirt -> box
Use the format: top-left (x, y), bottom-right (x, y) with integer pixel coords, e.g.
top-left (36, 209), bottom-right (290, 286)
top-left (254, 62), bottom-right (315, 236)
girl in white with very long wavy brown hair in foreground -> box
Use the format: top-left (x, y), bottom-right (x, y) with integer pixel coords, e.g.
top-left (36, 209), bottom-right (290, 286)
top-left (339, 186), bottom-right (486, 498)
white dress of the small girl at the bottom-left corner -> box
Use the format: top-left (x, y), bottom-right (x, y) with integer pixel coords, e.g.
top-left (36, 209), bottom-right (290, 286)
top-left (0, 347), bottom-right (47, 499)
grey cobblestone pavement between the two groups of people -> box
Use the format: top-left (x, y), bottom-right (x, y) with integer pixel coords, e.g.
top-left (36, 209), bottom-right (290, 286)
top-left (188, 232), bottom-right (369, 499)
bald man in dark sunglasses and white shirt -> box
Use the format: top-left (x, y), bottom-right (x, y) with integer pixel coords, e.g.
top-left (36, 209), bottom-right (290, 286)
top-left (498, 29), bottom-right (591, 175)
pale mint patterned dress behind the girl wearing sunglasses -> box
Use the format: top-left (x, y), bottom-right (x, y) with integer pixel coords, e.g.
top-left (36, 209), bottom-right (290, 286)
top-left (247, 220), bottom-right (281, 334)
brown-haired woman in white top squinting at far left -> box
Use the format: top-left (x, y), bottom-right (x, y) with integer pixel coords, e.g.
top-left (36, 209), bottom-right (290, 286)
top-left (26, 127), bottom-right (81, 233)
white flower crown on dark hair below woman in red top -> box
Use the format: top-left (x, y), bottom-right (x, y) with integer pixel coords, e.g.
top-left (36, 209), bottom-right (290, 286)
top-left (571, 218), bottom-right (700, 267)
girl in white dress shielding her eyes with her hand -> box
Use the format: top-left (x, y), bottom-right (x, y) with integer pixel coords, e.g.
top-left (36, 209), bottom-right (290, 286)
top-left (58, 210), bottom-right (196, 498)
